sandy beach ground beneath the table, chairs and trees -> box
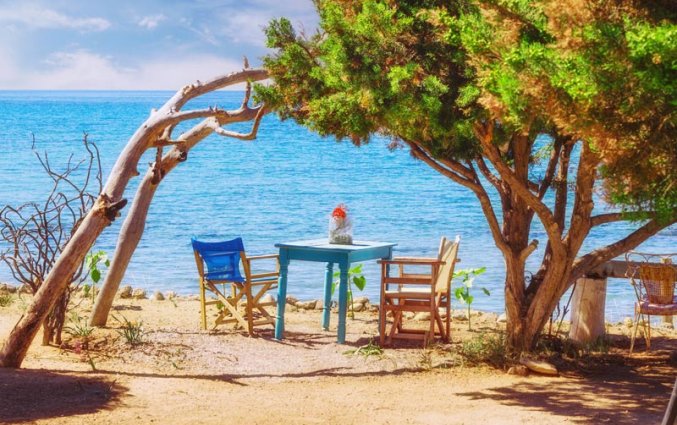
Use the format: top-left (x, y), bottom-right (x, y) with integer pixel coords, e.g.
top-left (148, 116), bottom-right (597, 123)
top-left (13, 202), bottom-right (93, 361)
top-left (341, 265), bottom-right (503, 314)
top-left (0, 292), bottom-right (677, 425)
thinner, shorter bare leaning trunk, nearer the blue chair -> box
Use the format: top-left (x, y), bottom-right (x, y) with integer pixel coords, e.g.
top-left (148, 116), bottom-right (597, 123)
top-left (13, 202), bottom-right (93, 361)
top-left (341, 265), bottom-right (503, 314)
top-left (89, 79), bottom-right (265, 326)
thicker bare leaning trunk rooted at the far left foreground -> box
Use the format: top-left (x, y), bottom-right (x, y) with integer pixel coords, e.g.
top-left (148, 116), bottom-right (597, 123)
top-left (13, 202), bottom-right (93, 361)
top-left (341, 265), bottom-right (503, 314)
top-left (0, 69), bottom-right (267, 367)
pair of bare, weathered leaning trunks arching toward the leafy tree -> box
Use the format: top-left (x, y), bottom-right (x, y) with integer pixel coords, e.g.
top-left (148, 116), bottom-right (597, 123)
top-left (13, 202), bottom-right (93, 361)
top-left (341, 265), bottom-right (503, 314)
top-left (0, 64), bottom-right (268, 367)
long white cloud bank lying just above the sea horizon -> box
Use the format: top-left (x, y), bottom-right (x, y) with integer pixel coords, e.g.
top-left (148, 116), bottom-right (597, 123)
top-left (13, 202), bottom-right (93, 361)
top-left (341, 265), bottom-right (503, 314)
top-left (0, 50), bottom-right (251, 90)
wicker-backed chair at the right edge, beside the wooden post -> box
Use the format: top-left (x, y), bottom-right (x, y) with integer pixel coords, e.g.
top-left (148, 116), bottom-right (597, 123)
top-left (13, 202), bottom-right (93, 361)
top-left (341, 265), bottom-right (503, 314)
top-left (630, 263), bottom-right (677, 353)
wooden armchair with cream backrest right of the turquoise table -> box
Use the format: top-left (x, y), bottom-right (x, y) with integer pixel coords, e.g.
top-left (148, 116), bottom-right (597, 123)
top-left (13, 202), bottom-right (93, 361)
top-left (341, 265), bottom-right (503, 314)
top-left (379, 236), bottom-right (460, 347)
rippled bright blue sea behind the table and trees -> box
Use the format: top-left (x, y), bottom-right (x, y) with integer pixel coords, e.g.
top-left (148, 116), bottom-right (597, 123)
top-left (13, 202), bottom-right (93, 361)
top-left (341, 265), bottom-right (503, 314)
top-left (0, 91), bottom-right (677, 320)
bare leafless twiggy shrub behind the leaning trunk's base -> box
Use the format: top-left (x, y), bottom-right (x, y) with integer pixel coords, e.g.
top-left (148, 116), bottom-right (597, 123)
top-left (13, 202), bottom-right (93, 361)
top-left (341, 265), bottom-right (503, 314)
top-left (0, 134), bottom-right (101, 345)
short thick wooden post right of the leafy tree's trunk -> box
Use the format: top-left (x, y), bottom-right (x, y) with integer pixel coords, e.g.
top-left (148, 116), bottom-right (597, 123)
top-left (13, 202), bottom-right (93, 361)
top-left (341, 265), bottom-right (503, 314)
top-left (569, 278), bottom-right (607, 344)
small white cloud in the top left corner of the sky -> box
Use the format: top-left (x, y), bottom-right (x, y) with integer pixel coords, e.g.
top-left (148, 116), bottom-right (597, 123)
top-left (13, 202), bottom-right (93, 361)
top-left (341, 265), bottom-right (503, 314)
top-left (0, 3), bottom-right (111, 31)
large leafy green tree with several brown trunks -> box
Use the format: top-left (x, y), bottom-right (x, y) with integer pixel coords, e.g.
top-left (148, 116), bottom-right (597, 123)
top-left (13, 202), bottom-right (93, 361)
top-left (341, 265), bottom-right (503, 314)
top-left (257, 0), bottom-right (677, 351)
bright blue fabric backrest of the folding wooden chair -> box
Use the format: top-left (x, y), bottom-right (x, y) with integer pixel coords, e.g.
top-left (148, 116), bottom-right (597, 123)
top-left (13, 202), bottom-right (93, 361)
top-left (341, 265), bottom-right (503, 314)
top-left (191, 238), bottom-right (245, 282)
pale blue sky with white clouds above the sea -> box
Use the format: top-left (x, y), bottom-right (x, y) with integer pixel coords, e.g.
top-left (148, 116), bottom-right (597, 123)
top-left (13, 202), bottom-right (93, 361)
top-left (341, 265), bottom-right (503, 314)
top-left (0, 0), bottom-right (318, 90)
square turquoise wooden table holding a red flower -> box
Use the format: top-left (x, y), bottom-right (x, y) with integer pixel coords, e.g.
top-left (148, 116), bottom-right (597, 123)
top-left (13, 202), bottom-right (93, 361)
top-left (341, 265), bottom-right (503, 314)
top-left (275, 239), bottom-right (396, 344)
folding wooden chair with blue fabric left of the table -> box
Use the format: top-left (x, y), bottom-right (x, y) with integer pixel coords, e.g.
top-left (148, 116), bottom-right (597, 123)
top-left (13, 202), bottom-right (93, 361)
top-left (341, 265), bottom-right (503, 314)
top-left (191, 238), bottom-right (280, 335)
